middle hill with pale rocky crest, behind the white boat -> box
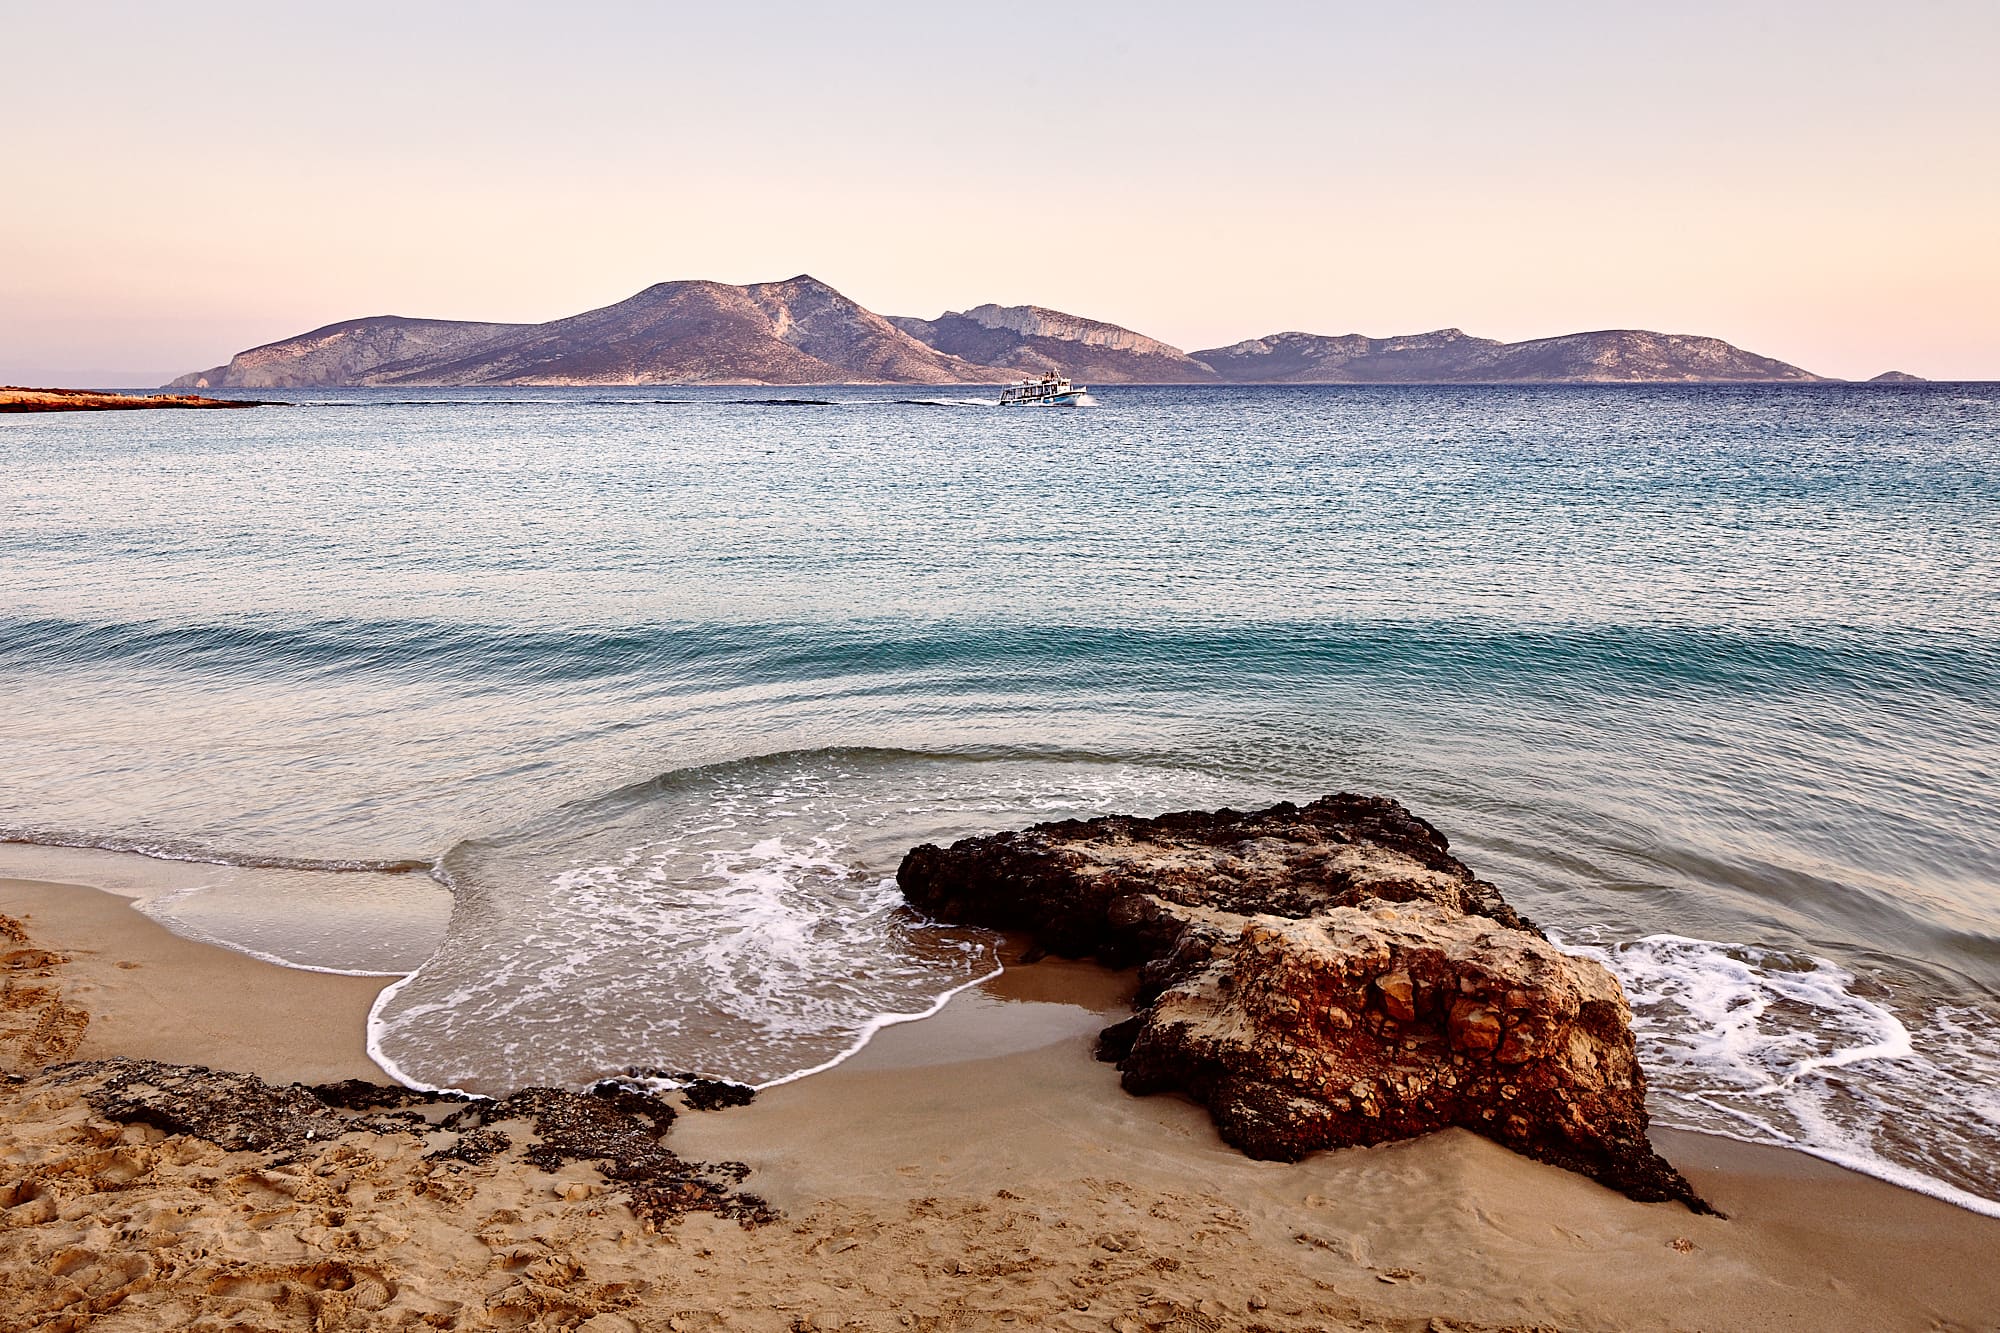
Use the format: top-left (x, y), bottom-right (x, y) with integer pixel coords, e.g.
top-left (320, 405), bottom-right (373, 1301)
top-left (890, 306), bottom-right (1220, 384)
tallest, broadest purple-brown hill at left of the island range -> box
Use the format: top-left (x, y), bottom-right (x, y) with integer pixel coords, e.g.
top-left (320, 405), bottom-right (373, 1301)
top-left (176, 276), bottom-right (1006, 388)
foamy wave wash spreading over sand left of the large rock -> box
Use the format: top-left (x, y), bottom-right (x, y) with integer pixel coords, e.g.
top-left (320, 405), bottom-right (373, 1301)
top-left (370, 751), bottom-right (1256, 1087)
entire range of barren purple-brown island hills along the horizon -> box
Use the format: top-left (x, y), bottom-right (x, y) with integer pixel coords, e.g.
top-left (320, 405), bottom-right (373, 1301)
top-left (168, 274), bottom-right (1822, 388)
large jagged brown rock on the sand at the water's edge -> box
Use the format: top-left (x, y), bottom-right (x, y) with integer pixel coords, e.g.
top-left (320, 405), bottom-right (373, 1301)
top-left (896, 795), bottom-right (1706, 1209)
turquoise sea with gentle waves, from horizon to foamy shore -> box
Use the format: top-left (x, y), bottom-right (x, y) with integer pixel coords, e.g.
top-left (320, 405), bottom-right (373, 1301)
top-left (0, 384), bottom-right (2000, 1209)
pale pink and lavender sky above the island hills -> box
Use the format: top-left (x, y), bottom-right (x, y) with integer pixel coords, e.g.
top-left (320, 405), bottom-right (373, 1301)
top-left (0, 0), bottom-right (2000, 382)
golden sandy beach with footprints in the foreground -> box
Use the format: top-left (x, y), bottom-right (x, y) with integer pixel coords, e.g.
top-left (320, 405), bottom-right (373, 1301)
top-left (0, 868), bottom-right (2000, 1331)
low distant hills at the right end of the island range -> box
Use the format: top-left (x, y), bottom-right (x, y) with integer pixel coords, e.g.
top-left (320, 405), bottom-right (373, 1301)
top-left (1194, 328), bottom-right (1820, 384)
